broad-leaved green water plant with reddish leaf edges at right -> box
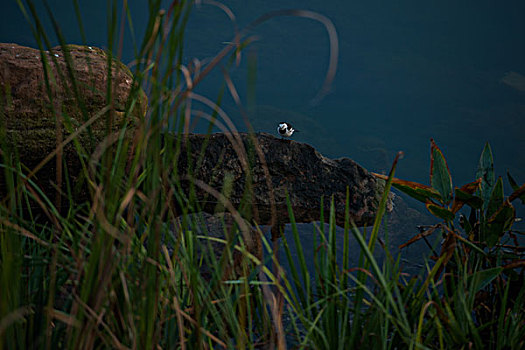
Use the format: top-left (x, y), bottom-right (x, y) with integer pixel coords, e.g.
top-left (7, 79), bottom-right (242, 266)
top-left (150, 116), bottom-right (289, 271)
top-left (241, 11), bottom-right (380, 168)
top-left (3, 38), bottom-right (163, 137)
top-left (375, 140), bottom-right (525, 348)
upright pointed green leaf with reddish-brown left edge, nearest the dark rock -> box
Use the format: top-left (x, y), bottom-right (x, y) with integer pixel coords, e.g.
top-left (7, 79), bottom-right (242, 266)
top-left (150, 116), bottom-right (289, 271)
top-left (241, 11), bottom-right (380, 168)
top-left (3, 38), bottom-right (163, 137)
top-left (430, 139), bottom-right (452, 204)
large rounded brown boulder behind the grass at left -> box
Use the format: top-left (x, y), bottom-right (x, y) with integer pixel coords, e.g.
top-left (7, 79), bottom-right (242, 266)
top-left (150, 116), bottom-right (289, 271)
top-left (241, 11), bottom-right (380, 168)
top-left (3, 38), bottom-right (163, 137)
top-left (0, 43), bottom-right (147, 204)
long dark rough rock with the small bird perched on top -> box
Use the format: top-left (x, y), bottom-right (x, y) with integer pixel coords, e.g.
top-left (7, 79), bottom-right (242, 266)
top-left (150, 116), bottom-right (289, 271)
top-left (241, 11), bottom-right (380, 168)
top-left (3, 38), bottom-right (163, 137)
top-left (170, 133), bottom-right (392, 231)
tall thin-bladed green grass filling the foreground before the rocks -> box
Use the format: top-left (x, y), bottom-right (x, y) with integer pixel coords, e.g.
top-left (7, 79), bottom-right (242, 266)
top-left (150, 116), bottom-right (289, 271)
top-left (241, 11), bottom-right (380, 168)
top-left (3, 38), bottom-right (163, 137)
top-left (0, 0), bottom-right (525, 349)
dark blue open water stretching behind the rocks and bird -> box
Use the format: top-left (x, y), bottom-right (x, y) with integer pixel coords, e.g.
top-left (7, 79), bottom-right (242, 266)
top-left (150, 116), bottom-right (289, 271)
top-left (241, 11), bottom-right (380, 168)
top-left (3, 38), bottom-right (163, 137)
top-left (0, 0), bottom-right (525, 230)
